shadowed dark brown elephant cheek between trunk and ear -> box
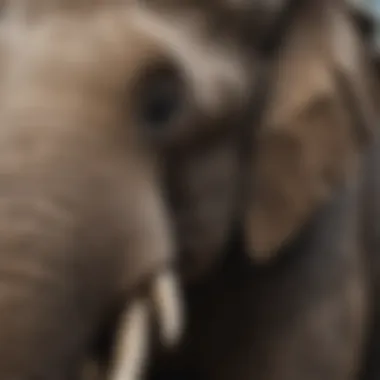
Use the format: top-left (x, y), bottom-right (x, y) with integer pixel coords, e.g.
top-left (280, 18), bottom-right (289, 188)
top-left (164, 138), bottom-right (240, 281)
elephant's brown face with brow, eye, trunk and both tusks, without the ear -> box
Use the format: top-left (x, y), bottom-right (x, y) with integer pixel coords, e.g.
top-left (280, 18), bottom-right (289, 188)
top-left (0, 0), bottom-right (249, 380)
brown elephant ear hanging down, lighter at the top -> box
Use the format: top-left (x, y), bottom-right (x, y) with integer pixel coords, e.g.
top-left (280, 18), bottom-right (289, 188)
top-left (244, 0), bottom-right (376, 260)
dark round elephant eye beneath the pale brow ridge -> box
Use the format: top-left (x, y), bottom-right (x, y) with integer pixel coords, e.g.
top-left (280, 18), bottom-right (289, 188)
top-left (135, 65), bottom-right (185, 137)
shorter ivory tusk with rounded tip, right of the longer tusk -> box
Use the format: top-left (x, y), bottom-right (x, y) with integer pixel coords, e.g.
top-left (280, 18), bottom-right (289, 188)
top-left (151, 271), bottom-right (184, 347)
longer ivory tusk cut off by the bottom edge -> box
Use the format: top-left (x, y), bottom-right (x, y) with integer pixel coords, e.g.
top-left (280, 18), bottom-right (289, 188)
top-left (108, 300), bottom-right (150, 380)
